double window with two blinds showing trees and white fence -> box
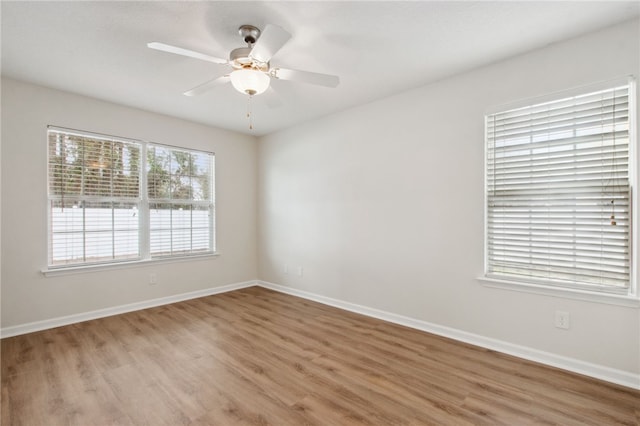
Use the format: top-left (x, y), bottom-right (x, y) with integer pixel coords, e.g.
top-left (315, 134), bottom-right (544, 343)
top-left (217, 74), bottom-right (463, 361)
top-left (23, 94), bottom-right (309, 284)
top-left (48, 127), bottom-right (215, 268)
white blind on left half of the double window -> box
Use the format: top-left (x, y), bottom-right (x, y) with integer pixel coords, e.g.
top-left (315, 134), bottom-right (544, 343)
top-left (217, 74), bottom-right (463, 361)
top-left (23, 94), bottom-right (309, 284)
top-left (48, 129), bottom-right (140, 266)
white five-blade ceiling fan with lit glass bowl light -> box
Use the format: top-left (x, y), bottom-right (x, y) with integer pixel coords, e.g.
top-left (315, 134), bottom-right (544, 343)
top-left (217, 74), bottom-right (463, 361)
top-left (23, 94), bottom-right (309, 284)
top-left (147, 24), bottom-right (340, 97)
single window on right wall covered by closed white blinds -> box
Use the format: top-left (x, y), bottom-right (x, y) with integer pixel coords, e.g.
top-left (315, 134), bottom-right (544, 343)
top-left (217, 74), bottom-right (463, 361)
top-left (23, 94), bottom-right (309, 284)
top-left (485, 80), bottom-right (633, 293)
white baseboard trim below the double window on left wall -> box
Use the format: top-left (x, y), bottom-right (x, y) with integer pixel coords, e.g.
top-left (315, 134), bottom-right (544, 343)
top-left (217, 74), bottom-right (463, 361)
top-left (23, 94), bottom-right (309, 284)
top-left (0, 281), bottom-right (257, 339)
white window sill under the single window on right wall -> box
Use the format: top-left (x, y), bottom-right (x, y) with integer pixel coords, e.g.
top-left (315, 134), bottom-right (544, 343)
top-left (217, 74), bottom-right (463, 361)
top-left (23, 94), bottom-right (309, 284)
top-left (477, 277), bottom-right (640, 308)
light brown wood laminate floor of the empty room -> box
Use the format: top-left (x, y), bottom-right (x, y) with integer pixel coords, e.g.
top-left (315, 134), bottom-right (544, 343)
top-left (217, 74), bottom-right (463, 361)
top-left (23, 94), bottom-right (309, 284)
top-left (1, 287), bottom-right (640, 426)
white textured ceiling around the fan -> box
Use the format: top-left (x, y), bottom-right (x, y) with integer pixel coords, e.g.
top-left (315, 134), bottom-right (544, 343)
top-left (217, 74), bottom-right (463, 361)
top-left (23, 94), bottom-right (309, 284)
top-left (1, 1), bottom-right (640, 135)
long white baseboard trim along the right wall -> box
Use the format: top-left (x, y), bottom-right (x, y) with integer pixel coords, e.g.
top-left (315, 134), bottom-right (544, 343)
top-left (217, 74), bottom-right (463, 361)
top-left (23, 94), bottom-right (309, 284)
top-left (257, 281), bottom-right (640, 390)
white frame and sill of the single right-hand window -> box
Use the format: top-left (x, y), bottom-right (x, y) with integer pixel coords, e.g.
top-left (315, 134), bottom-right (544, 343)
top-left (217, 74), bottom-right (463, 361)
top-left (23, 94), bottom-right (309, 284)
top-left (478, 76), bottom-right (640, 308)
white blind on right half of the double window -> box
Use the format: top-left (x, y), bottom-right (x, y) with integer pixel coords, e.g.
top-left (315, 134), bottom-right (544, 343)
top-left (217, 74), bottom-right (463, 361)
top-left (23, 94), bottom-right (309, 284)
top-left (147, 145), bottom-right (214, 257)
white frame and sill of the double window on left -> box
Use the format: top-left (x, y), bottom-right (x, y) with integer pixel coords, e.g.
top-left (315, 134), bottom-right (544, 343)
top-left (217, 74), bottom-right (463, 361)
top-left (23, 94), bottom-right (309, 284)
top-left (41, 125), bottom-right (219, 276)
